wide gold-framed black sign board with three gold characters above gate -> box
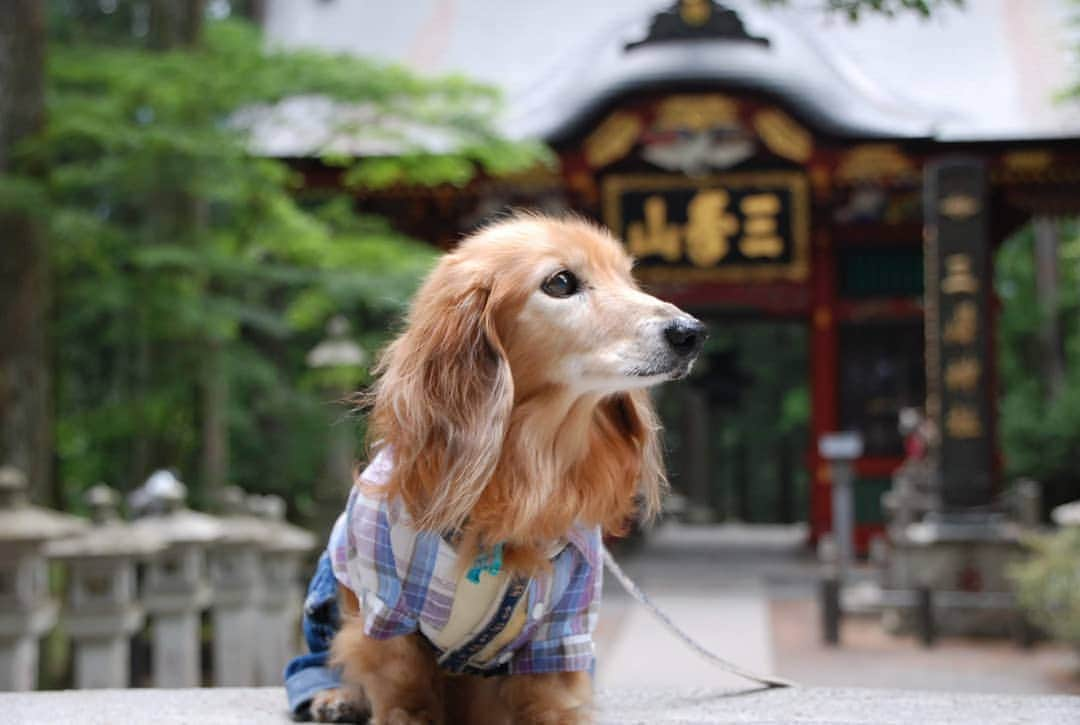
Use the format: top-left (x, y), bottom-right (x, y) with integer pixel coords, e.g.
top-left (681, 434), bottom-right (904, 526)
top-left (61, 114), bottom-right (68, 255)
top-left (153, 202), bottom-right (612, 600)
top-left (604, 172), bottom-right (810, 282)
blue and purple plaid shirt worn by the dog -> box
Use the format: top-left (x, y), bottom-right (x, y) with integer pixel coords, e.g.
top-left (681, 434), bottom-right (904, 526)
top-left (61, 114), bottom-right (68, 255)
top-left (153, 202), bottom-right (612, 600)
top-left (328, 451), bottom-right (604, 674)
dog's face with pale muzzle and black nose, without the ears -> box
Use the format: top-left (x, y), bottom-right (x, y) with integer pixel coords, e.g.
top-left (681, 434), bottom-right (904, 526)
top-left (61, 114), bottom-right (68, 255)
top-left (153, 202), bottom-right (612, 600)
top-left (492, 219), bottom-right (705, 397)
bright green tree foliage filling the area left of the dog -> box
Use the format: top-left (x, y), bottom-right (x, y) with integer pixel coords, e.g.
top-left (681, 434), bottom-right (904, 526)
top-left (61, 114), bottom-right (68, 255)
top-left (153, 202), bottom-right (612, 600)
top-left (12, 5), bottom-right (540, 516)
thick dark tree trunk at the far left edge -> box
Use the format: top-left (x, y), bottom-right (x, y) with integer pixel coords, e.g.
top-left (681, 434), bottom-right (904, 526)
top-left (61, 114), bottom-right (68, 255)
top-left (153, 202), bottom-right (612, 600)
top-left (0, 0), bottom-right (55, 502)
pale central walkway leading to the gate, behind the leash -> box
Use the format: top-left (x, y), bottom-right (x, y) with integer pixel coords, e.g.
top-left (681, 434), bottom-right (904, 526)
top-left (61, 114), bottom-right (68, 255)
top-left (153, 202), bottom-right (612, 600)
top-left (596, 524), bottom-right (812, 688)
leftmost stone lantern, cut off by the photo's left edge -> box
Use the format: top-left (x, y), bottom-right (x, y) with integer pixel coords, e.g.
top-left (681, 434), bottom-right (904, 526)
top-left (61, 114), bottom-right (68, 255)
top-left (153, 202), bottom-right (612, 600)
top-left (0, 466), bottom-right (86, 690)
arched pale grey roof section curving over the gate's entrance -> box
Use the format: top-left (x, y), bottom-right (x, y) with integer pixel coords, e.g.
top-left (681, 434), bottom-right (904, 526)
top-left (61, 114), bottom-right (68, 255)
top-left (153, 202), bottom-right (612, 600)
top-left (505, 3), bottom-right (943, 143)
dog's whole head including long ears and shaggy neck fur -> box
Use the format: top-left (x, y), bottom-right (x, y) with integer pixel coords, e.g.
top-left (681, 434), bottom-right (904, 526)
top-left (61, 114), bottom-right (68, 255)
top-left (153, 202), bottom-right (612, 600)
top-left (370, 216), bottom-right (705, 546)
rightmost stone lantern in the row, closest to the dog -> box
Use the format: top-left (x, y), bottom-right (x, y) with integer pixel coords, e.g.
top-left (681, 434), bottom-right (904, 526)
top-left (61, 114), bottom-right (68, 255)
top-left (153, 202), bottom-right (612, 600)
top-left (247, 495), bottom-right (315, 685)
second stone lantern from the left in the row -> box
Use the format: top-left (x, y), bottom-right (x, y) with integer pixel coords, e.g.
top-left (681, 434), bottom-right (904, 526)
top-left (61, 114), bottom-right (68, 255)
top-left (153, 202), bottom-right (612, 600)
top-left (46, 484), bottom-right (164, 689)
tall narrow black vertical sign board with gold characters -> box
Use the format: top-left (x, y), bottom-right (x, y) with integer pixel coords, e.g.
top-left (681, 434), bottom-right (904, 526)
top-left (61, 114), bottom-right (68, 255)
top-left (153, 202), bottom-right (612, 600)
top-left (923, 159), bottom-right (994, 510)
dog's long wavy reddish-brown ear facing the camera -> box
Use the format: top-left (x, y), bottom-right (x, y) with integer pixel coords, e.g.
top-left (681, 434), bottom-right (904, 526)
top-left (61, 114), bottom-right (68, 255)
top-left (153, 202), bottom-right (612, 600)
top-left (368, 258), bottom-right (514, 532)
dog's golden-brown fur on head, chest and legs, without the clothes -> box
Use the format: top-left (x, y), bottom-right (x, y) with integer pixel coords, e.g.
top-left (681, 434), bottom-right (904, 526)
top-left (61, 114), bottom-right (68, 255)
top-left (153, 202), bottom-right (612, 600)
top-left (316, 216), bottom-right (685, 723)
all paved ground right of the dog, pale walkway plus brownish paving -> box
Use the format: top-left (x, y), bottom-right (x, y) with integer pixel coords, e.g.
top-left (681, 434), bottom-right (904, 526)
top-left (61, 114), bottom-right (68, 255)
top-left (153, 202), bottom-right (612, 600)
top-left (597, 524), bottom-right (1080, 695)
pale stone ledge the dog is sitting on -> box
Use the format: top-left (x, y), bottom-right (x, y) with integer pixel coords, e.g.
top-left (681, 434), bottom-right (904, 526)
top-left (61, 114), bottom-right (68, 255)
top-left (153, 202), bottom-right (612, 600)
top-left (0, 687), bottom-right (1080, 725)
